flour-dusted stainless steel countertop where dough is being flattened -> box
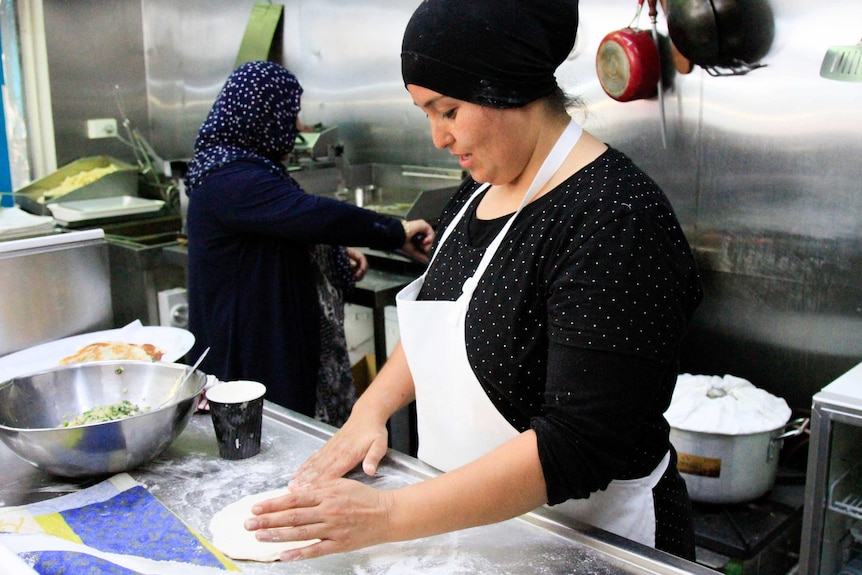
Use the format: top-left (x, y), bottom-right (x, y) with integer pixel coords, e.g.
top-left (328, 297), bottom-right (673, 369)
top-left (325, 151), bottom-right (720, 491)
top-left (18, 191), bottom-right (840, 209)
top-left (0, 403), bottom-right (715, 575)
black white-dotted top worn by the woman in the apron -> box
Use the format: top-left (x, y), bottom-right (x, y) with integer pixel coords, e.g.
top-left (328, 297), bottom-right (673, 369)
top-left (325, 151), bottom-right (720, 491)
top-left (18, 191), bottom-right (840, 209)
top-left (420, 149), bottom-right (702, 503)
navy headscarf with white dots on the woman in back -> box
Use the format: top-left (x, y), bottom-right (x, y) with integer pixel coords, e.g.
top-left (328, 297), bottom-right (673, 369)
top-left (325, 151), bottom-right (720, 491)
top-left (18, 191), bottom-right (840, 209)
top-left (186, 61), bottom-right (302, 191)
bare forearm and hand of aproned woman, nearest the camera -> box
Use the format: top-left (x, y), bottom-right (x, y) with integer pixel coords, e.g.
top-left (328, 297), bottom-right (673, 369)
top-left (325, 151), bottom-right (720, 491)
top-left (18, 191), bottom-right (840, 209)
top-left (250, 430), bottom-right (547, 561)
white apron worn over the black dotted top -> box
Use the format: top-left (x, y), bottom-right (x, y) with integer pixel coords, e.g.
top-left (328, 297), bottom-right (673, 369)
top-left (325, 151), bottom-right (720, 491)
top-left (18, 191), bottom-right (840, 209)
top-left (395, 121), bottom-right (670, 546)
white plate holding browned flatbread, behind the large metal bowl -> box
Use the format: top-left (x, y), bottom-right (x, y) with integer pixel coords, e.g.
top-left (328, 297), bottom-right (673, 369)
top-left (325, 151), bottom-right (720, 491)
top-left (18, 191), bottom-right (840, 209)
top-left (0, 322), bottom-right (195, 382)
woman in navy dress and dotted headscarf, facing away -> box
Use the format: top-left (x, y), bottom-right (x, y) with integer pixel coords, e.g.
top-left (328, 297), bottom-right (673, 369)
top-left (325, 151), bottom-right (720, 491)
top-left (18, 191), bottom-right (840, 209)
top-left (187, 62), bottom-right (433, 417)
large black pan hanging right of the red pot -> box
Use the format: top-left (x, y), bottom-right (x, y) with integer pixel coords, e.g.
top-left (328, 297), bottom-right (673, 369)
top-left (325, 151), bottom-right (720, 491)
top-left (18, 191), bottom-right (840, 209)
top-left (666, 0), bottom-right (775, 75)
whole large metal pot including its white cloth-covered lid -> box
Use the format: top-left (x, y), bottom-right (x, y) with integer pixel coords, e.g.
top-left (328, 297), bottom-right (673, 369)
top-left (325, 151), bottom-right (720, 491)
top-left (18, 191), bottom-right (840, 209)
top-left (665, 374), bottom-right (807, 504)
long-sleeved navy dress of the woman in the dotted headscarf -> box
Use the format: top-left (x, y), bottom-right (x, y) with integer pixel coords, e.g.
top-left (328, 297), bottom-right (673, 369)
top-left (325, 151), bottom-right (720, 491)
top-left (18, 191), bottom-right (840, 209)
top-left (187, 159), bottom-right (404, 416)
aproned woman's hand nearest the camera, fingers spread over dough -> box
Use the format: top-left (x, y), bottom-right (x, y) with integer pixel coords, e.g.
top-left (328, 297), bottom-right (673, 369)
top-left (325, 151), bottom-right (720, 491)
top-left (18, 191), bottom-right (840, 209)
top-left (245, 478), bottom-right (393, 561)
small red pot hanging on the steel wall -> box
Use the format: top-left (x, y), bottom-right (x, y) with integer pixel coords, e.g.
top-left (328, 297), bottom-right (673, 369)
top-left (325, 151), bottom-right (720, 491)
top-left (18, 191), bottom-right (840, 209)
top-left (596, 27), bottom-right (661, 102)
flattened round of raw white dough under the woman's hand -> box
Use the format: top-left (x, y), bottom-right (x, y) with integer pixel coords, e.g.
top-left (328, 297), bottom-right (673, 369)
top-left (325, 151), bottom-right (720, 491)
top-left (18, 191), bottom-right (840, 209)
top-left (210, 488), bottom-right (320, 561)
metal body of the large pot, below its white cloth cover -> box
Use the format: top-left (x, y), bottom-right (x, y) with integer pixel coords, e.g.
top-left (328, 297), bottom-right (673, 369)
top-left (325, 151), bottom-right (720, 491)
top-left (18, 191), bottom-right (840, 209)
top-left (670, 419), bottom-right (808, 503)
